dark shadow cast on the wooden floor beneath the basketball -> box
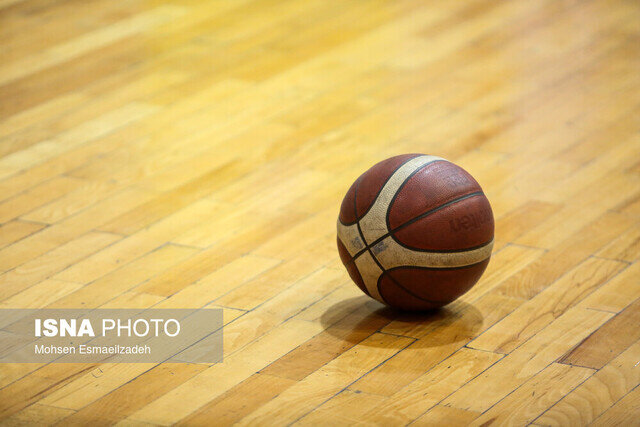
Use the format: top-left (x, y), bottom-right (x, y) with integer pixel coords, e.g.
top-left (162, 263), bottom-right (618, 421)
top-left (320, 295), bottom-right (484, 349)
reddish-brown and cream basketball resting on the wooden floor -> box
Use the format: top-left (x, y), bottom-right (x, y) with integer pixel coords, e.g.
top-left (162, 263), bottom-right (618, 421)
top-left (338, 154), bottom-right (494, 310)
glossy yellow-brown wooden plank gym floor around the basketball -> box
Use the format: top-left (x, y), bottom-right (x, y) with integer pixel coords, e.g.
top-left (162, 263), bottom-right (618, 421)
top-left (0, 0), bottom-right (640, 426)
